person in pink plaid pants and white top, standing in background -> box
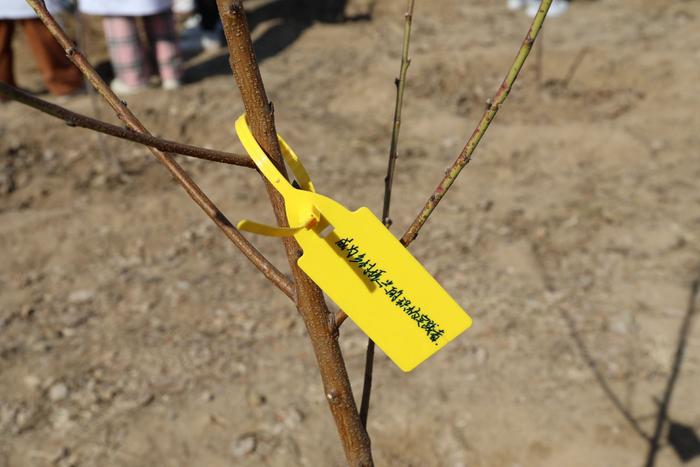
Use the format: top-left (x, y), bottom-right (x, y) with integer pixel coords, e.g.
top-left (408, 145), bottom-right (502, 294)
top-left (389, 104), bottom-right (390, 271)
top-left (78, 0), bottom-right (182, 94)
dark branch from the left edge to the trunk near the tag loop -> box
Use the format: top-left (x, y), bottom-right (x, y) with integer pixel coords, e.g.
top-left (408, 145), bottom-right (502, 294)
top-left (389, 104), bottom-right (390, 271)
top-left (0, 81), bottom-right (255, 168)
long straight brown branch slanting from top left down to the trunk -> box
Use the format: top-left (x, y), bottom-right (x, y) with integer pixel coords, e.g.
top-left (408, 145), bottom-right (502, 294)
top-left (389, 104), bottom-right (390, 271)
top-left (27, 0), bottom-right (296, 299)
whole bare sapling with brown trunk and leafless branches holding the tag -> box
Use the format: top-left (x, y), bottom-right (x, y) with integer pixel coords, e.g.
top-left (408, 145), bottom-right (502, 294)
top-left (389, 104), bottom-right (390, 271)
top-left (0, 0), bottom-right (552, 466)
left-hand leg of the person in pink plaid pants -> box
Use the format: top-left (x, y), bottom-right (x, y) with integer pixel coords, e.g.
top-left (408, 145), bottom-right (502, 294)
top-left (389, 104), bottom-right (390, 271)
top-left (102, 16), bottom-right (149, 92)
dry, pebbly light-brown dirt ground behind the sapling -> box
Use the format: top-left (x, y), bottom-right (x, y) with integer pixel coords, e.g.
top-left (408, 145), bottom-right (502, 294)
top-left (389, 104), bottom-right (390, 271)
top-left (0, 0), bottom-right (700, 467)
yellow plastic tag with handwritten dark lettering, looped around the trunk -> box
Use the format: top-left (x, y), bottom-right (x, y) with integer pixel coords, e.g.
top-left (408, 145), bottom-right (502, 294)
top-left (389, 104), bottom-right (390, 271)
top-left (236, 115), bottom-right (472, 371)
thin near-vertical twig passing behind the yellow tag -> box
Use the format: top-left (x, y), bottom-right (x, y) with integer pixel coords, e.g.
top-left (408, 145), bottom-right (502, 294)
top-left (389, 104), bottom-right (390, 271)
top-left (360, 0), bottom-right (416, 434)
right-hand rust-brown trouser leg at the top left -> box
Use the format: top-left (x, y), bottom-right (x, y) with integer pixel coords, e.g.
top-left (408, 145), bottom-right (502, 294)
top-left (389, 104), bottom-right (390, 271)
top-left (18, 18), bottom-right (83, 96)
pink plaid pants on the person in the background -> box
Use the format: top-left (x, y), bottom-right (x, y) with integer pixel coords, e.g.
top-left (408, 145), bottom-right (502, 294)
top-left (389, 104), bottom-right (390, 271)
top-left (102, 10), bottom-right (182, 86)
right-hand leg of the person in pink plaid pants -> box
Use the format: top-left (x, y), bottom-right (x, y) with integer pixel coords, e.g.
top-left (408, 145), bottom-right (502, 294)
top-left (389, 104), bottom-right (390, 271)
top-left (143, 10), bottom-right (182, 89)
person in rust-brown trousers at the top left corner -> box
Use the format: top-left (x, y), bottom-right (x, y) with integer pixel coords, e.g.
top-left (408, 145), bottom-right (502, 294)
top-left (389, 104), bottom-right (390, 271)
top-left (0, 0), bottom-right (83, 96)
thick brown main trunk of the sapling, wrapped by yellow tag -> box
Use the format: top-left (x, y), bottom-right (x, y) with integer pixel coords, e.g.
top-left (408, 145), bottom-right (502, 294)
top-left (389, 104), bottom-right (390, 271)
top-left (217, 0), bottom-right (374, 467)
